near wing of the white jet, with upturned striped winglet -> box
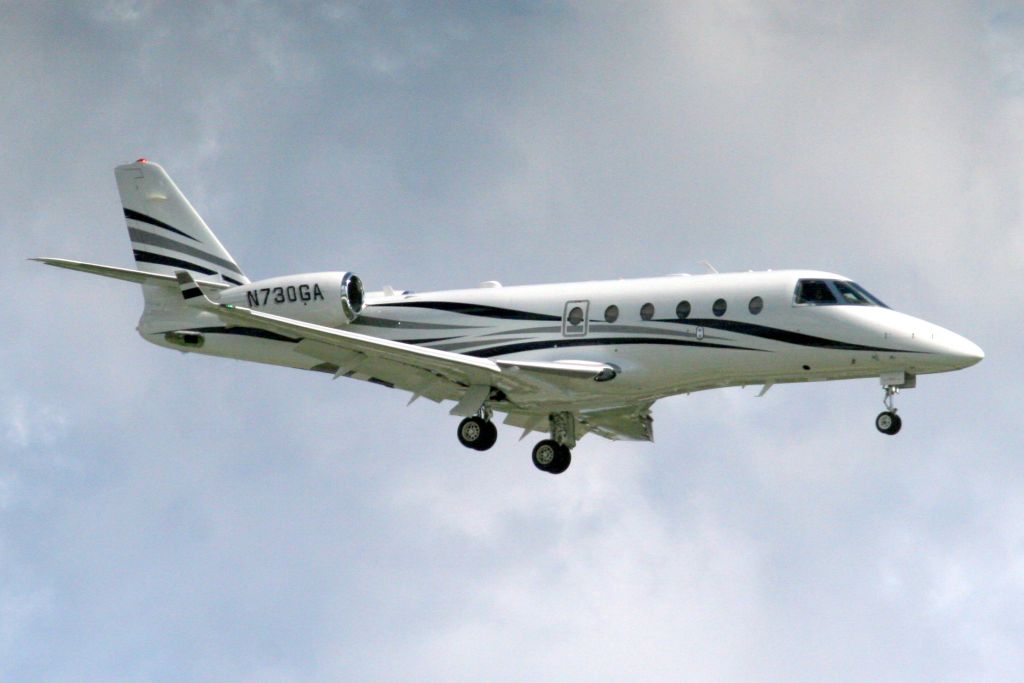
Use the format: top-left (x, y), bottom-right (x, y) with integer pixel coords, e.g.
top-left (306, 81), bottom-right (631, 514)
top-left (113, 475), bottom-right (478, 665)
top-left (176, 270), bottom-right (617, 416)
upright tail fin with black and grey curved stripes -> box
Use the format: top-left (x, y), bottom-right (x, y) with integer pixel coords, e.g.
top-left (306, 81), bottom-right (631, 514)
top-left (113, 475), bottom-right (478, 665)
top-left (114, 159), bottom-right (249, 285)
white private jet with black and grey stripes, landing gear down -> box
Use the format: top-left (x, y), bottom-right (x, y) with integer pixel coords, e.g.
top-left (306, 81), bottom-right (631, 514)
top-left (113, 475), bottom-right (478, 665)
top-left (33, 159), bottom-right (984, 474)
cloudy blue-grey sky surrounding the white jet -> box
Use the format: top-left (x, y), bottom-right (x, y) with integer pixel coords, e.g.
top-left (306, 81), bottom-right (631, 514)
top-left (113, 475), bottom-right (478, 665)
top-left (0, 0), bottom-right (1024, 682)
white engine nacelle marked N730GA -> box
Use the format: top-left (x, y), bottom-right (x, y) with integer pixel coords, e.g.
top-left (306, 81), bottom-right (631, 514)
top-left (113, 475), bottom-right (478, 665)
top-left (217, 272), bottom-right (364, 327)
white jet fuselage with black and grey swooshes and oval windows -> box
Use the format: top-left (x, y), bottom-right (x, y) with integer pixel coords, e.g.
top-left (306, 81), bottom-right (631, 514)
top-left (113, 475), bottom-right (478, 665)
top-left (140, 270), bottom-right (983, 411)
